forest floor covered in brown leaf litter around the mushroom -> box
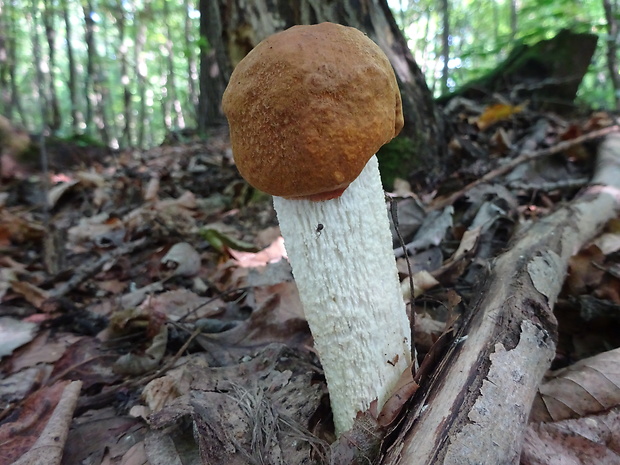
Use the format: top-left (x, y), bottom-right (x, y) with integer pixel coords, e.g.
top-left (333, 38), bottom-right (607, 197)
top-left (0, 104), bottom-right (620, 465)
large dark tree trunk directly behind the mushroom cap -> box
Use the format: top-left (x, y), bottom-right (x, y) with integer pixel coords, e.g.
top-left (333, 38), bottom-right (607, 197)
top-left (206, 0), bottom-right (446, 177)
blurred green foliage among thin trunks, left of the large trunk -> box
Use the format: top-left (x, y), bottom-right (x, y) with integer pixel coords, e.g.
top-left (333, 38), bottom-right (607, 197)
top-left (0, 0), bottom-right (199, 146)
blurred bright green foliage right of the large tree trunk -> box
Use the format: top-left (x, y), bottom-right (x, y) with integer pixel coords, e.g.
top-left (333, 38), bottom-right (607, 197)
top-left (390, 0), bottom-right (613, 108)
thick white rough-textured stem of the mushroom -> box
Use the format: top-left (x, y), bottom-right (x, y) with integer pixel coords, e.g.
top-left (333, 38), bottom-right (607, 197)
top-left (273, 156), bottom-right (411, 434)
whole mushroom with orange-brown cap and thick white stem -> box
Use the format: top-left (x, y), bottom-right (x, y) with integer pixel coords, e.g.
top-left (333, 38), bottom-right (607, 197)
top-left (222, 23), bottom-right (412, 434)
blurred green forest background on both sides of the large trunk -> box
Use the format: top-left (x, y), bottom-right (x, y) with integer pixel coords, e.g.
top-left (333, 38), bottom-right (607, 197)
top-left (0, 0), bottom-right (620, 148)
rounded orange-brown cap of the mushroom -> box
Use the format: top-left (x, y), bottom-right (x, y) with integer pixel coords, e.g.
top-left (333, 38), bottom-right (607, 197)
top-left (222, 23), bottom-right (403, 199)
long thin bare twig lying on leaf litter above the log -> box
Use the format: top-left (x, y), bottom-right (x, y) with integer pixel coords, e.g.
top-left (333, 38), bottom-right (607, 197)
top-left (430, 124), bottom-right (620, 210)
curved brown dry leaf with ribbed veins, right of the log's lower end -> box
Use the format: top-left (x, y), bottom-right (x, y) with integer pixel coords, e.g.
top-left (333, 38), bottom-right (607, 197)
top-left (530, 349), bottom-right (620, 422)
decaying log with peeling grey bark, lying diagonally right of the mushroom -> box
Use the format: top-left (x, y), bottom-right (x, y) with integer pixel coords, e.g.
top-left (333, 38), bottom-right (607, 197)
top-left (382, 134), bottom-right (620, 465)
